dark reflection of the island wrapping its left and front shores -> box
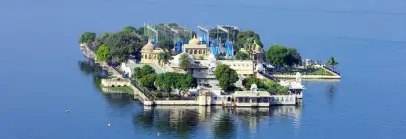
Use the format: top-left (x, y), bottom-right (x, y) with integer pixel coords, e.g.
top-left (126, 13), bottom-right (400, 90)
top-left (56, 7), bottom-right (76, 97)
top-left (79, 61), bottom-right (302, 139)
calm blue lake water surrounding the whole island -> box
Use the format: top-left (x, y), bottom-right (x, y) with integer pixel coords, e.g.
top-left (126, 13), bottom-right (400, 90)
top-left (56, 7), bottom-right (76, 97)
top-left (0, 0), bottom-right (406, 139)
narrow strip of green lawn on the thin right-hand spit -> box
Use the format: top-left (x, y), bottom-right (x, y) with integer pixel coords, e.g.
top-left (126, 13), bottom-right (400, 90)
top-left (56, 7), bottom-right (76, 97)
top-left (275, 68), bottom-right (333, 76)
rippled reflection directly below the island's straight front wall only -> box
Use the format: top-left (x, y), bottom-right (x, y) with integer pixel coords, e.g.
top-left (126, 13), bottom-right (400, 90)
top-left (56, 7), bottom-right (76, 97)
top-left (138, 106), bottom-right (301, 139)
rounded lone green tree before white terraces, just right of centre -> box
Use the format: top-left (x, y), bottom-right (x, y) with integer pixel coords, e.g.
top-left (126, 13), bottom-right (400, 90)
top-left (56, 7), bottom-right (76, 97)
top-left (214, 64), bottom-right (238, 91)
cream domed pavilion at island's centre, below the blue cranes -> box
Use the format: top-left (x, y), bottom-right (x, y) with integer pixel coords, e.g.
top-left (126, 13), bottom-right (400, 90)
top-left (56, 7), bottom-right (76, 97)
top-left (183, 36), bottom-right (208, 58)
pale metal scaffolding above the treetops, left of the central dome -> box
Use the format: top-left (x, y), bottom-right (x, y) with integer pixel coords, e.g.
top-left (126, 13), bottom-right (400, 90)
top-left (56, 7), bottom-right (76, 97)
top-left (144, 23), bottom-right (193, 43)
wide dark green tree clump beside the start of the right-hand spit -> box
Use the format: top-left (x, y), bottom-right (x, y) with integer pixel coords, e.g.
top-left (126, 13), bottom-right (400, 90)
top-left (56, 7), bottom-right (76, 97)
top-left (265, 45), bottom-right (302, 66)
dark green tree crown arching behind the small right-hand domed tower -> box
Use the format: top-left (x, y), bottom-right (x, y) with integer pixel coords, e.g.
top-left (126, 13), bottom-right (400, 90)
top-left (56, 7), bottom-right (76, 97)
top-left (235, 30), bottom-right (263, 51)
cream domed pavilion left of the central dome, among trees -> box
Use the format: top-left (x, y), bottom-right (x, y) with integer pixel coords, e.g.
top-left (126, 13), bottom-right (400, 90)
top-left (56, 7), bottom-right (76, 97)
top-left (141, 41), bottom-right (164, 63)
